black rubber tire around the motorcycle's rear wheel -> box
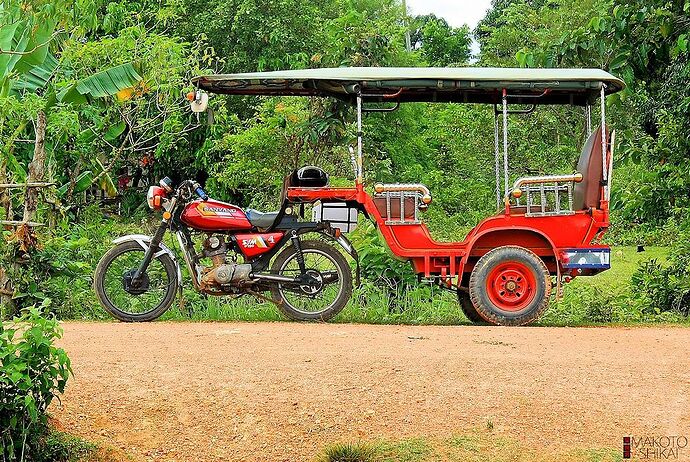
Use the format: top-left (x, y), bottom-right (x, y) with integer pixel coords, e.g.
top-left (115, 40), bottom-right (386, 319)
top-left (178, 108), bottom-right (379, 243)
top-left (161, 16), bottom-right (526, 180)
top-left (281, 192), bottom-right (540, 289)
top-left (271, 241), bottom-right (352, 322)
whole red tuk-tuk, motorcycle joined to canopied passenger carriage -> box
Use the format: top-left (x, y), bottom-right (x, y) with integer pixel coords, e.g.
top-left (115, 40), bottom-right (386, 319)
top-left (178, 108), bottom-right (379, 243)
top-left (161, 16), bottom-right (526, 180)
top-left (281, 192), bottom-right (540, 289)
top-left (96, 68), bottom-right (624, 325)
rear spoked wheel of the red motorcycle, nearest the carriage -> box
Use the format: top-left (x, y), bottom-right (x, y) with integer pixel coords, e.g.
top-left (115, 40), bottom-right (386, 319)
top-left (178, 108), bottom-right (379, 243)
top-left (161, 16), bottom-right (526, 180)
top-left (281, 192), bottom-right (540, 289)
top-left (271, 241), bottom-right (352, 321)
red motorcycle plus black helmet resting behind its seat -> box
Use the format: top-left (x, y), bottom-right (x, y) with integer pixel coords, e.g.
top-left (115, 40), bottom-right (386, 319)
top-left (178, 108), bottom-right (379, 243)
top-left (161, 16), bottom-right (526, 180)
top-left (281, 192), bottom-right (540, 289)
top-left (94, 167), bottom-right (357, 322)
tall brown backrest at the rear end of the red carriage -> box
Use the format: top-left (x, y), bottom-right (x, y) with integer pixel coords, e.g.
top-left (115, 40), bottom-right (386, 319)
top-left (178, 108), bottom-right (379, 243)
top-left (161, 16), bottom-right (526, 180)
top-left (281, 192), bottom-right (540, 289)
top-left (573, 127), bottom-right (608, 210)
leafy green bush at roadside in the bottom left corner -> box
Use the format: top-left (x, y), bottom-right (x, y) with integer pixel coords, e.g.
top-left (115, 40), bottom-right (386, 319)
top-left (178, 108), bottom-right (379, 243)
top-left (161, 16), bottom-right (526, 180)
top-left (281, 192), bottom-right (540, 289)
top-left (0, 308), bottom-right (72, 461)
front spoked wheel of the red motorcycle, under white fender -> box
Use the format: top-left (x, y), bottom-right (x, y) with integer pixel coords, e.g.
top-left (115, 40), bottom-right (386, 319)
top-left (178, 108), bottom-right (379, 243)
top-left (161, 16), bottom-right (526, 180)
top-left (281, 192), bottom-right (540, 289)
top-left (94, 242), bottom-right (179, 322)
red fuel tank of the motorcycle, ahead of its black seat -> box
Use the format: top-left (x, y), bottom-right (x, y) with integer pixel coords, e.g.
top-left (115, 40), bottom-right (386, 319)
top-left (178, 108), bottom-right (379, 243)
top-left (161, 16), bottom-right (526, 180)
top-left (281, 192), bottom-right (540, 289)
top-left (180, 199), bottom-right (252, 231)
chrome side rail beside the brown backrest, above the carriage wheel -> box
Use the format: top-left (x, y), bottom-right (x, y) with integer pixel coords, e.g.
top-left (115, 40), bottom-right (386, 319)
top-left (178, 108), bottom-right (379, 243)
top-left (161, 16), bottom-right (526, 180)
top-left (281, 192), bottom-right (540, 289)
top-left (508, 173), bottom-right (582, 217)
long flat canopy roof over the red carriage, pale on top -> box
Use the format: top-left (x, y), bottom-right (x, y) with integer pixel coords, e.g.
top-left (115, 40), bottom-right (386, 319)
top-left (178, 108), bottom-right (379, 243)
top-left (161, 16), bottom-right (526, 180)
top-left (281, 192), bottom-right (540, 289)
top-left (192, 67), bottom-right (625, 105)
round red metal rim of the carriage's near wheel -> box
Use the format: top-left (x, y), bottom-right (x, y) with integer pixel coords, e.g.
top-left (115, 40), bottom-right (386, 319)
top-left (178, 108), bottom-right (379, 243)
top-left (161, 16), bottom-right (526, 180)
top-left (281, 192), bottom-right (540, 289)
top-left (486, 261), bottom-right (537, 311)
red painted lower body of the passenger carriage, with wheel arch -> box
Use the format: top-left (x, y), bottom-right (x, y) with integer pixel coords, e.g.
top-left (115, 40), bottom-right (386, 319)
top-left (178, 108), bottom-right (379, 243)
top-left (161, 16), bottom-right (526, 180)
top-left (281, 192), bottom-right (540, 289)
top-left (287, 185), bottom-right (609, 284)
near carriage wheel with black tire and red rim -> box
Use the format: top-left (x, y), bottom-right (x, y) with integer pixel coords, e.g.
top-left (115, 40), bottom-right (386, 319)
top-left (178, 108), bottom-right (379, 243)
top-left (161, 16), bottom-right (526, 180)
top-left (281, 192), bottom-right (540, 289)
top-left (469, 245), bottom-right (551, 326)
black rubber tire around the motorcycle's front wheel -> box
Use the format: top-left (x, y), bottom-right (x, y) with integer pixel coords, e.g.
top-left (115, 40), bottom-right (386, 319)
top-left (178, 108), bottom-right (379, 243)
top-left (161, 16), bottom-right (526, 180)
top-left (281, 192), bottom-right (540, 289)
top-left (93, 241), bottom-right (180, 322)
